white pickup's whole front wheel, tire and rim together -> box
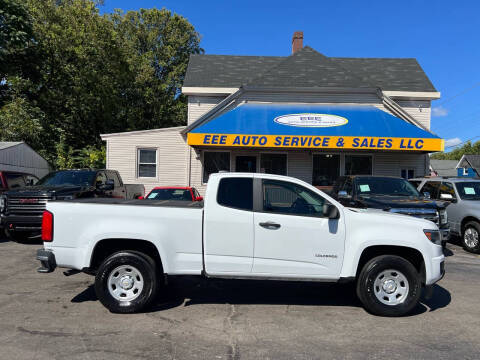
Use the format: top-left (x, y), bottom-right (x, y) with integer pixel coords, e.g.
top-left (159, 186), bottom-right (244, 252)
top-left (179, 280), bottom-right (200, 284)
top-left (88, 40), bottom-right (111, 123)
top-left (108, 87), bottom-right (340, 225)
top-left (357, 255), bottom-right (422, 316)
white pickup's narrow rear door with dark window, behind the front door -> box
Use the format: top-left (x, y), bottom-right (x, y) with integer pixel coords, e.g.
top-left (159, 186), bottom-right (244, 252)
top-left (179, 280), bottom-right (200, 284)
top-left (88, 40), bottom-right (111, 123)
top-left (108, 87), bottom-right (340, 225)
top-left (204, 175), bottom-right (254, 275)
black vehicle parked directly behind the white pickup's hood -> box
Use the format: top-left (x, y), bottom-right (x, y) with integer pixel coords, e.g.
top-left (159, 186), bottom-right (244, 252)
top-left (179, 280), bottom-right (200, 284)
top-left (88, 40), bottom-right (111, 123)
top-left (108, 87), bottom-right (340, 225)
top-left (332, 175), bottom-right (450, 245)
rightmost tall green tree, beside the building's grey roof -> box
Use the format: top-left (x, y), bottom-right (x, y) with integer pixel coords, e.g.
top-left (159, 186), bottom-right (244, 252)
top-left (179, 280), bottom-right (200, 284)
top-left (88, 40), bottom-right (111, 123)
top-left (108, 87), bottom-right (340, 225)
top-left (110, 9), bottom-right (203, 129)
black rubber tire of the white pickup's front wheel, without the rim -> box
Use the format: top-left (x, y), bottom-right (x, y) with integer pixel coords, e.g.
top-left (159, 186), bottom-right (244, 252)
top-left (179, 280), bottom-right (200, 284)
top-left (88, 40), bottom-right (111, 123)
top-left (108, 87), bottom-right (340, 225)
top-left (357, 255), bottom-right (422, 316)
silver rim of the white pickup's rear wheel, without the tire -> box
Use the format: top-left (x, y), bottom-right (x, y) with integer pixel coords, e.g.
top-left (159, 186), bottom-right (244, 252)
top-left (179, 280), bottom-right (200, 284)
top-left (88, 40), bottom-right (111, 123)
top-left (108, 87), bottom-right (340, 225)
top-left (108, 265), bottom-right (143, 301)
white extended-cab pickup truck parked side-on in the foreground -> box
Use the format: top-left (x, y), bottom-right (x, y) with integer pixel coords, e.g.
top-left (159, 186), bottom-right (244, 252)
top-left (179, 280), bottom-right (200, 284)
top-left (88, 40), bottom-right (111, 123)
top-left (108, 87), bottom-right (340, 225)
top-left (37, 173), bottom-right (444, 316)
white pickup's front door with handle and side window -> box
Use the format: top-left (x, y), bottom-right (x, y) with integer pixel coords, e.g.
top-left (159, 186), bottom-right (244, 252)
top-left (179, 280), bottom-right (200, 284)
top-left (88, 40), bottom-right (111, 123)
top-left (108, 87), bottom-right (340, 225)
top-left (252, 179), bottom-right (345, 278)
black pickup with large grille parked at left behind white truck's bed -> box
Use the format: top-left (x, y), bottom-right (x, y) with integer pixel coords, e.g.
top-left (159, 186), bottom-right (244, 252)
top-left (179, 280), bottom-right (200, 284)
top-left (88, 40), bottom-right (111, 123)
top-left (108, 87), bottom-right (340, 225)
top-left (0, 169), bottom-right (145, 240)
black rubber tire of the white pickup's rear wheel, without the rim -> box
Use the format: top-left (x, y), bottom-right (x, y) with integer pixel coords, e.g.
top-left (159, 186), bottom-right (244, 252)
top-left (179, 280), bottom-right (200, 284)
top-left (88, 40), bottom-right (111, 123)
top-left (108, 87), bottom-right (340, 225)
top-left (95, 251), bottom-right (158, 313)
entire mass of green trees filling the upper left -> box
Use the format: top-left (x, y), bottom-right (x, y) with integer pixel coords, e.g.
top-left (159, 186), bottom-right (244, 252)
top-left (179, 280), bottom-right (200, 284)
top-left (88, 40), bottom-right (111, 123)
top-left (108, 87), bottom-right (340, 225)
top-left (0, 0), bottom-right (202, 168)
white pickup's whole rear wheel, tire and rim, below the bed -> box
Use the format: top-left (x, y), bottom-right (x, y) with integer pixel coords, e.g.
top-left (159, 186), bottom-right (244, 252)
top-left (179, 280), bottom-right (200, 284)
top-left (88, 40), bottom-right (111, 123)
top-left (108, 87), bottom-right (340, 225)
top-left (95, 251), bottom-right (157, 313)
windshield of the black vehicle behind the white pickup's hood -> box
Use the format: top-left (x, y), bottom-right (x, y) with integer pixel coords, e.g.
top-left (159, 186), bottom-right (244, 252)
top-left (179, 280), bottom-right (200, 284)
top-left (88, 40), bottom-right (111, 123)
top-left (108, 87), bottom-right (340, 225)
top-left (355, 177), bottom-right (420, 197)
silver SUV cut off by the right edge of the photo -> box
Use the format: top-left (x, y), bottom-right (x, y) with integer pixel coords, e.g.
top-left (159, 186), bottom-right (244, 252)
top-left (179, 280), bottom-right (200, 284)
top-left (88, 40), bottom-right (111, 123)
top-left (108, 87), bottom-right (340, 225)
top-left (410, 177), bottom-right (480, 254)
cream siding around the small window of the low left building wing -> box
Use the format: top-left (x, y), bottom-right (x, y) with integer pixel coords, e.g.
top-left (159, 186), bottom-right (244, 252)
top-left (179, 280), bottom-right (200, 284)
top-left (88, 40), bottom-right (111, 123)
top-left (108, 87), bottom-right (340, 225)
top-left (106, 127), bottom-right (188, 192)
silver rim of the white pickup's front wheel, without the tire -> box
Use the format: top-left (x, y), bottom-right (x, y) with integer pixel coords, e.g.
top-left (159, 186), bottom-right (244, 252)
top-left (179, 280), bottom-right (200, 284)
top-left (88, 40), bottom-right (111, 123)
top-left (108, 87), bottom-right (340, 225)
top-left (373, 269), bottom-right (408, 306)
